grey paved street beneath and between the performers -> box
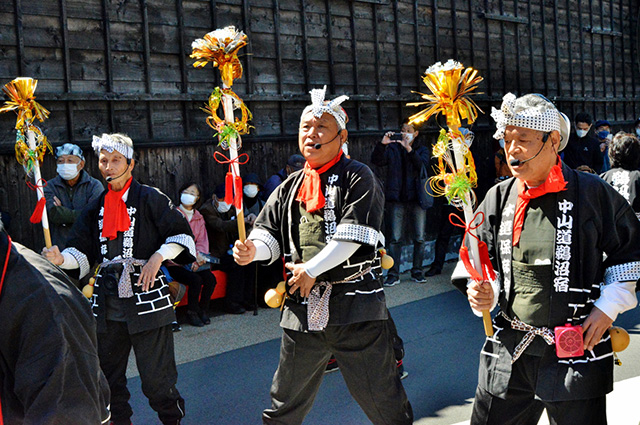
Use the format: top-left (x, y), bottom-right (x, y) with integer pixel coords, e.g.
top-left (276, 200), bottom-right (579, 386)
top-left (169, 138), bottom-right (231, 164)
top-left (129, 264), bottom-right (640, 425)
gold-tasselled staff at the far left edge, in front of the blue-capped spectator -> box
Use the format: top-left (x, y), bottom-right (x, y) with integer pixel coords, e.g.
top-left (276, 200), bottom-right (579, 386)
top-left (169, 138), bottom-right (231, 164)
top-left (0, 77), bottom-right (51, 248)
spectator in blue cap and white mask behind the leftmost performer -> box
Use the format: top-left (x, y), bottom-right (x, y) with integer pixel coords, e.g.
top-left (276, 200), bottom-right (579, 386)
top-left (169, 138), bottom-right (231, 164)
top-left (44, 143), bottom-right (104, 250)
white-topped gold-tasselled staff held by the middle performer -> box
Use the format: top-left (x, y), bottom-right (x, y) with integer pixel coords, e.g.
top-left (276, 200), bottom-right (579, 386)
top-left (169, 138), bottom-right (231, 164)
top-left (191, 26), bottom-right (252, 242)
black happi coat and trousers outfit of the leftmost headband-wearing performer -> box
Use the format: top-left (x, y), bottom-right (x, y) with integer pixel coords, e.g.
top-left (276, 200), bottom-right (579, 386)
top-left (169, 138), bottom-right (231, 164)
top-left (63, 178), bottom-right (195, 425)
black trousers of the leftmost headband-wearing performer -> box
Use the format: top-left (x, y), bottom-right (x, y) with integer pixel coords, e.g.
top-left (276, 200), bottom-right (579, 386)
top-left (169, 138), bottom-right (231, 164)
top-left (98, 320), bottom-right (184, 425)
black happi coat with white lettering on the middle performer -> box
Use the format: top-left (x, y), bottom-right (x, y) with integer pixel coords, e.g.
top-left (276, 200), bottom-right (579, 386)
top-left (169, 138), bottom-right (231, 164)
top-left (249, 156), bottom-right (387, 331)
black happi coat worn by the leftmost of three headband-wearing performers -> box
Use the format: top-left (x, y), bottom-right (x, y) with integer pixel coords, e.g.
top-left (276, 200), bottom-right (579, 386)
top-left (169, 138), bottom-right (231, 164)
top-left (67, 179), bottom-right (195, 334)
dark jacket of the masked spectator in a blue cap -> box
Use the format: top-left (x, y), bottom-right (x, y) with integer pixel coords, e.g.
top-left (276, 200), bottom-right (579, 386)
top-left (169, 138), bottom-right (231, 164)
top-left (44, 170), bottom-right (104, 250)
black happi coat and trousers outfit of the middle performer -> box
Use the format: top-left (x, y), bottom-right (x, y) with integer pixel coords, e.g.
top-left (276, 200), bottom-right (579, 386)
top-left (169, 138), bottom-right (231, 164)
top-left (249, 157), bottom-right (413, 424)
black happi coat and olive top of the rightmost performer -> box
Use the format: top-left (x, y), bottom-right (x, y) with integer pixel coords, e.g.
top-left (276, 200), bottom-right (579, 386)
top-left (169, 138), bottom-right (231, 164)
top-left (454, 164), bottom-right (640, 424)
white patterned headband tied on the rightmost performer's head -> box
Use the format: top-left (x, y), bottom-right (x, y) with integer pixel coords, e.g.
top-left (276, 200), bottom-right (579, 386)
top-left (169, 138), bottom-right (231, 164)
top-left (491, 93), bottom-right (562, 140)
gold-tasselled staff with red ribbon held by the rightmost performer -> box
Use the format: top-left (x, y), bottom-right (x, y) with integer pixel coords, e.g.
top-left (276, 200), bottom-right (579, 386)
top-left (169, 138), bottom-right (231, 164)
top-left (408, 59), bottom-right (495, 336)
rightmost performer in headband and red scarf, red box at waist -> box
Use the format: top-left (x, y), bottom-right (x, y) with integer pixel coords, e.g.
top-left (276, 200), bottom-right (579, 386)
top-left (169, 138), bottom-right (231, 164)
top-left (453, 93), bottom-right (640, 425)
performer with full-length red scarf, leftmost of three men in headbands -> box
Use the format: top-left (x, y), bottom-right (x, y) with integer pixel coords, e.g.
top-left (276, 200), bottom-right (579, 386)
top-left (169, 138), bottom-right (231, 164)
top-left (43, 134), bottom-right (196, 425)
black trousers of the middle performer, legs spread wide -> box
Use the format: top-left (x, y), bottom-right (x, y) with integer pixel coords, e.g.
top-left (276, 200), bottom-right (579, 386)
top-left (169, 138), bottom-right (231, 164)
top-left (262, 320), bottom-right (413, 425)
